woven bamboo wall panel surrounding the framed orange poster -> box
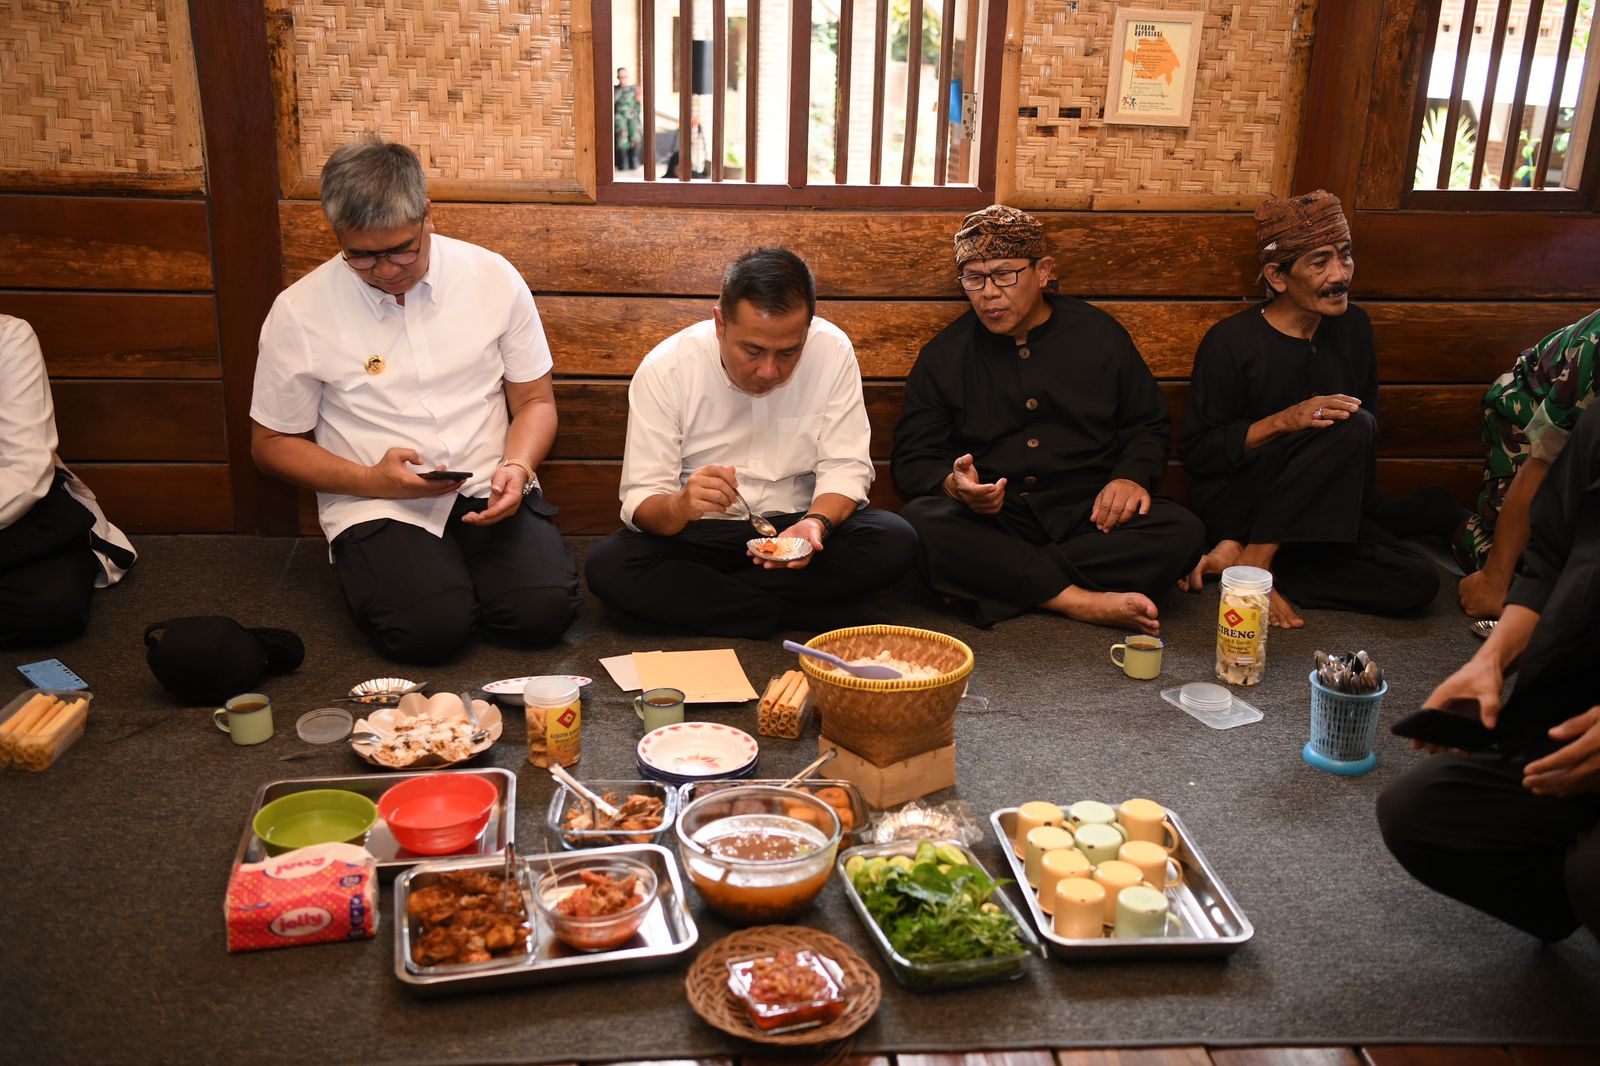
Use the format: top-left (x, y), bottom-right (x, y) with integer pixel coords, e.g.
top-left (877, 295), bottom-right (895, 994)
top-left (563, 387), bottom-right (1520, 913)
top-left (1016, 0), bottom-right (1312, 206)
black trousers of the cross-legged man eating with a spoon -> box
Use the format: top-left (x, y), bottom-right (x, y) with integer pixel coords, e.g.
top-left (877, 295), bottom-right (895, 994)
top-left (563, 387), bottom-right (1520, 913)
top-left (584, 507), bottom-right (917, 637)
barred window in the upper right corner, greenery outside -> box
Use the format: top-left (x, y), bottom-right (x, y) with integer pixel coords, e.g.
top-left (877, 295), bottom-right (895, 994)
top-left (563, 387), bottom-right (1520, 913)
top-left (1406, 0), bottom-right (1600, 210)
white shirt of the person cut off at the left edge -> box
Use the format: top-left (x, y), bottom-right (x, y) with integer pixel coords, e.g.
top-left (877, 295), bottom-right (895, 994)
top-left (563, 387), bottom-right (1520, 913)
top-left (0, 315), bottom-right (133, 589)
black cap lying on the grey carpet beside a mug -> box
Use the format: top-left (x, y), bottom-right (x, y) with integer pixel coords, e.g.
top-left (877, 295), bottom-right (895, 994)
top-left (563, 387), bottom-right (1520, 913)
top-left (144, 615), bottom-right (306, 704)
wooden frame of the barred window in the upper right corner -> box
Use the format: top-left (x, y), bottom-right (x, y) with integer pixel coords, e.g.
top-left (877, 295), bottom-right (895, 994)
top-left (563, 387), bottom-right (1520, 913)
top-left (1400, 0), bottom-right (1600, 211)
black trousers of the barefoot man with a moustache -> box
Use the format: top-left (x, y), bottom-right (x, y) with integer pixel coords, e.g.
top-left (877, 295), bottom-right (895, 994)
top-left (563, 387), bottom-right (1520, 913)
top-left (1195, 411), bottom-right (1438, 615)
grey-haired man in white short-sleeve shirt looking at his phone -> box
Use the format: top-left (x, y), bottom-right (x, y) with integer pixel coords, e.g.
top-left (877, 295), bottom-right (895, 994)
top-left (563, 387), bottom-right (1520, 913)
top-left (250, 134), bottom-right (578, 663)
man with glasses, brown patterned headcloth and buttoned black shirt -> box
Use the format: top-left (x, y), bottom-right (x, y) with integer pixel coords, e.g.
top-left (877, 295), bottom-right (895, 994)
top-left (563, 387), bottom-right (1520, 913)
top-left (891, 205), bottom-right (1205, 634)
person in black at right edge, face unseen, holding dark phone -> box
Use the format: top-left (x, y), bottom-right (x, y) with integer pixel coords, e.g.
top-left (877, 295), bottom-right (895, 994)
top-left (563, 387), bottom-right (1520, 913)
top-left (1378, 405), bottom-right (1600, 940)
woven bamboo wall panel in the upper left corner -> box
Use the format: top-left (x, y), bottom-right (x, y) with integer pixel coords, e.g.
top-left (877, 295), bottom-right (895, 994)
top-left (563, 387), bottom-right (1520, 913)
top-left (0, 0), bottom-right (205, 192)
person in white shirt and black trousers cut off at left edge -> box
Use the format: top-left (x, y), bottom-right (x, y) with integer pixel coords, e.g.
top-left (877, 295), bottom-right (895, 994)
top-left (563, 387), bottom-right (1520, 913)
top-left (0, 315), bottom-right (134, 647)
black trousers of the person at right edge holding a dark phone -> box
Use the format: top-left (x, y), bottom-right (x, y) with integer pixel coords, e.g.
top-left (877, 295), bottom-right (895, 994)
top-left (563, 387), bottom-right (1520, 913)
top-left (1378, 754), bottom-right (1600, 940)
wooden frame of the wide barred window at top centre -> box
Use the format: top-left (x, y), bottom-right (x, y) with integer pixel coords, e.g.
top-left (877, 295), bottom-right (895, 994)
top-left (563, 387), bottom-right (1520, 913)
top-left (594, 0), bottom-right (1018, 210)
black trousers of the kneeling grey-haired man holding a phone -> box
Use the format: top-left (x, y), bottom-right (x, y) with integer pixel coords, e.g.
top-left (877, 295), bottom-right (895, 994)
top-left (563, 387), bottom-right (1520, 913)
top-left (333, 496), bottom-right (578, 663)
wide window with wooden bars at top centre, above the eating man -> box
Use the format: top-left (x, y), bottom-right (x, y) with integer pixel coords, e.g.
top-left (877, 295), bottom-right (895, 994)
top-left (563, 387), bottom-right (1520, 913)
top-left (594, 0), bottom-right (1006, 208)
